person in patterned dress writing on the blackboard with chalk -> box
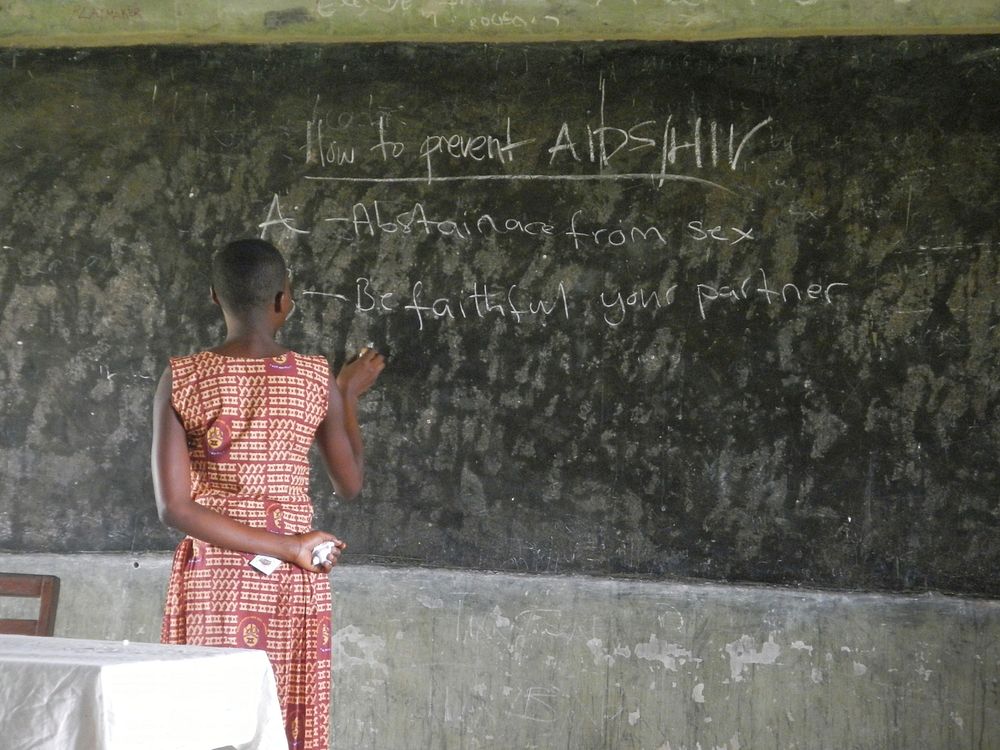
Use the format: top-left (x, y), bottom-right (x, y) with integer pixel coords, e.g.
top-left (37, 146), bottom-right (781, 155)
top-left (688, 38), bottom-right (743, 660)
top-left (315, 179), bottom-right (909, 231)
top-left (152, 240), bottom-right (385, 750)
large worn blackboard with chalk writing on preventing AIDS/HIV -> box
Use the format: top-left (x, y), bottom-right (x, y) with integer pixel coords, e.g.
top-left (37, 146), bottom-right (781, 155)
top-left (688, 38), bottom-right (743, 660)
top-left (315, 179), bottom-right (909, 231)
top-left (0, 37), bottom-right (1000, 595)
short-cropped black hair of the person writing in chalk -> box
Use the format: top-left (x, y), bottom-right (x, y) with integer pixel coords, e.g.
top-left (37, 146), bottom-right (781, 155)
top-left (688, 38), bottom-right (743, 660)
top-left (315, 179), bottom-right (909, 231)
top-left (212, 239), bottom-right (288, 312)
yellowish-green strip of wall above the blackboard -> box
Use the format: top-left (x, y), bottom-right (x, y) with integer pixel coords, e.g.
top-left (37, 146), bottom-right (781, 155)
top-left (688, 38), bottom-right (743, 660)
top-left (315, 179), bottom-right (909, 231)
top-left (0, 0), bottom-right (1000, 47)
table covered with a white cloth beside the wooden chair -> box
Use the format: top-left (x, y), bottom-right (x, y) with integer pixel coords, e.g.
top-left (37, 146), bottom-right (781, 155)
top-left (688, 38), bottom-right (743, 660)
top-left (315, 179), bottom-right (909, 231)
top-left (0, 635), bottom-right (288, 750)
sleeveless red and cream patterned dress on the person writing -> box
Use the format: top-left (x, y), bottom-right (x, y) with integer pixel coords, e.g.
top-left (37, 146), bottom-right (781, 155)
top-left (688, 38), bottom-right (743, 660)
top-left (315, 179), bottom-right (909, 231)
top-left (161, 352), bottom-right (331, 750)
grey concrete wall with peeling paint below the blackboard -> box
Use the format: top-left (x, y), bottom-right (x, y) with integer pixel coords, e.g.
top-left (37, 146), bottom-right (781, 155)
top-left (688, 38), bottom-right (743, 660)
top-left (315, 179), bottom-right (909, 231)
top-left (0, 554), bottom-right (1000, 750)
